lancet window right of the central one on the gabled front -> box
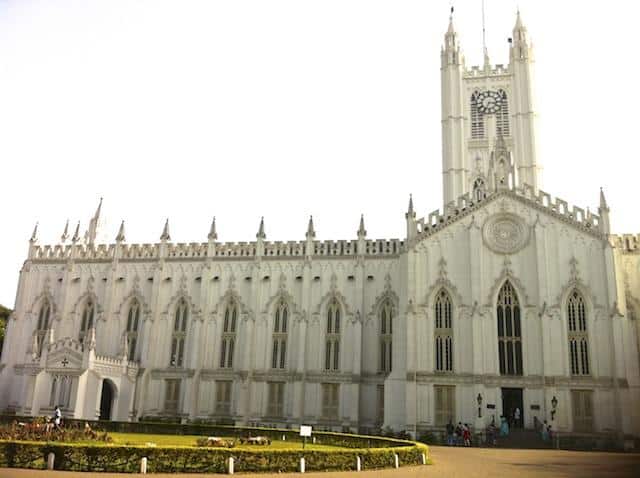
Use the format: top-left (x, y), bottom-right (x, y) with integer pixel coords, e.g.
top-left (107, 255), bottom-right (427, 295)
top-left (567, 290), bottom-right (590, 375)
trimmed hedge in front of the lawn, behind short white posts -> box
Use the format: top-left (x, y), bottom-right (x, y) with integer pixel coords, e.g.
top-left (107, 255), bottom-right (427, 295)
top-left (0, 441), bottom-right (428, 473)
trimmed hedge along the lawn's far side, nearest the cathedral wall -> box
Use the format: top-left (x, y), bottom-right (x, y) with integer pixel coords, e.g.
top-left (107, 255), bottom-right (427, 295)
top-left (0, 415), bottom-right (413, 448)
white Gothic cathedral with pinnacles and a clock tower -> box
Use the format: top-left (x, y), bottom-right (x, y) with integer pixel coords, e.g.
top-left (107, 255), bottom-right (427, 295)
top-left (0, 14), bottom-right (640, 437)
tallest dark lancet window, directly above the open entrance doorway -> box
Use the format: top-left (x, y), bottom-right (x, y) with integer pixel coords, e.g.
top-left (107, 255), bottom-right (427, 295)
top-left (496, 281), bottom-right (522, 375)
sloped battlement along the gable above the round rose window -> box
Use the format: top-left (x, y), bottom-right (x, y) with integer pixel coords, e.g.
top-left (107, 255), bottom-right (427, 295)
top-left (417, 184), bottom-right (601, 241)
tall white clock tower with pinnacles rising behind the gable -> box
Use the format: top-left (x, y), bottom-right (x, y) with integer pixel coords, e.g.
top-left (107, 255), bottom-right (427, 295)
top-left (440, 12), bottom-right (541, 206)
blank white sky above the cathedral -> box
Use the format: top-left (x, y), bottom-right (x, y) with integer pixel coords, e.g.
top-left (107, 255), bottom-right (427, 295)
top-left (0, 0), bottom-right (640, 307)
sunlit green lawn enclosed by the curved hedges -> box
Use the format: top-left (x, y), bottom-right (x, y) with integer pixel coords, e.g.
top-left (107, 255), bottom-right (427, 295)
top-left (109, 433), bottom-right (346, 450)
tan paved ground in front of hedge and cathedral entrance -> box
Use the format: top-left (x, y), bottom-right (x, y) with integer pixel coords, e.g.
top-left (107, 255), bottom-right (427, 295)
top-left (0, 446), bottom-right (640, 478)
